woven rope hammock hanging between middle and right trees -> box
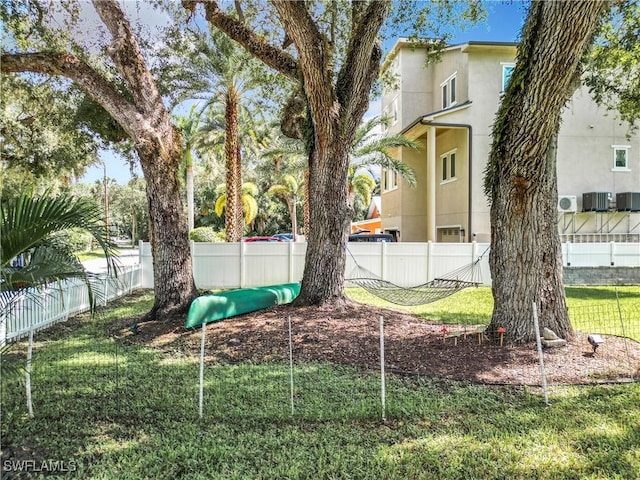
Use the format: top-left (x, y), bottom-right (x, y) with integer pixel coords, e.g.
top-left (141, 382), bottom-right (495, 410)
top-left (345, 252), bottom-right (486, 306)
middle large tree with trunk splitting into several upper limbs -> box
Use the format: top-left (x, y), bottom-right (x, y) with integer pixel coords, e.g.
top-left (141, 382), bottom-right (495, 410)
top-left (188, 0), bottom-right (391, 304)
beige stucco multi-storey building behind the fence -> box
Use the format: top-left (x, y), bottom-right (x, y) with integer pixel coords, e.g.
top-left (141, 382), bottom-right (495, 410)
top-left (381, 40), bottom-right (640, 242)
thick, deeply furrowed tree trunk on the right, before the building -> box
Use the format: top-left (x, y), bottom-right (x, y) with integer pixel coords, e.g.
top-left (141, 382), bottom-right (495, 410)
top-left (485, 1), bottom-right (607, 343)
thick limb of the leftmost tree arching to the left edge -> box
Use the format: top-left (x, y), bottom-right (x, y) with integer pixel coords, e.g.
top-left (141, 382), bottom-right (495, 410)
top-left (0, 52), bottom-right (140, 137)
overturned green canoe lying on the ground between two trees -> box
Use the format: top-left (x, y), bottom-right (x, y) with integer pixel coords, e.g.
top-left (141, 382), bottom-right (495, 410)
top-left (185, 283), bottom-right (300, 328)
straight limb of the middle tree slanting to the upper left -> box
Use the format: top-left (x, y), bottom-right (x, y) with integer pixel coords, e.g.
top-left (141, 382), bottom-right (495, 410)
top-left (191, 0), bottom-right (299, 81)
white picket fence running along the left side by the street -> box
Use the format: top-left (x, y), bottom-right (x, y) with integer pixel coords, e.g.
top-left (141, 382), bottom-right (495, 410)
top-left (0, 265), bottom-right (142, 345)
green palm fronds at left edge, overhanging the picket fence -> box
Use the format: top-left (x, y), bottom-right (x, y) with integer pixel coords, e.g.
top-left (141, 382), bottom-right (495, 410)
top-left (0, 191), bottom-right (115, 344)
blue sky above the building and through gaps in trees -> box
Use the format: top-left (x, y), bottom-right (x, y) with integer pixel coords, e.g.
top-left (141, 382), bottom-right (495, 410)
top-left (80, 0), bottom-right (527, 185)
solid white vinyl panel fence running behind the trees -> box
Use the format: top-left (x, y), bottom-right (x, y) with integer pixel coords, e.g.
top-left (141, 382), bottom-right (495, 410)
top-left (140, 242), bottom-right (640, 289)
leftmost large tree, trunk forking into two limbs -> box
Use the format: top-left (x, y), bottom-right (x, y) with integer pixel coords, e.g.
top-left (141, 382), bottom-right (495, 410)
top-left (1, 0), bottom-right (197, 317)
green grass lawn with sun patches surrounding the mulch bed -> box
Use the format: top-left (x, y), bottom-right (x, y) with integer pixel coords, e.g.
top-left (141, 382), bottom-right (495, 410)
top-left (1, 289), bottom-right (640, 480)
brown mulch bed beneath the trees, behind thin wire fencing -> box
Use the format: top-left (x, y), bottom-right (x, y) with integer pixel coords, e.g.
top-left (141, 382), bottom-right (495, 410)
top-left (118, 303), bottom-right (640, 385)
